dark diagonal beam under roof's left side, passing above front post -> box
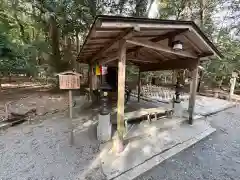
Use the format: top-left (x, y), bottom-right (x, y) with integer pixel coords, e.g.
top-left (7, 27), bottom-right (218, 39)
top-left (91, 27), bottom-right (137, 62)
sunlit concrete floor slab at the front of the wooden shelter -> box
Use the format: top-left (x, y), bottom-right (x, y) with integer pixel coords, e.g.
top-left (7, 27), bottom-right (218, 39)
top-left (101, 120), bottom-right (215, 180)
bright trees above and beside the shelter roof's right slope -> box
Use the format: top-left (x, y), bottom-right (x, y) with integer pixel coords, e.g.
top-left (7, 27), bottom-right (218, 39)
top-left (156, 0), bottom-right (240, 89)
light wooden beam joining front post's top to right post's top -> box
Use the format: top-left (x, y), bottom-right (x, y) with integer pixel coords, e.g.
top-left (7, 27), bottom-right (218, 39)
top-left (127, 38), bottom-right (197, 59)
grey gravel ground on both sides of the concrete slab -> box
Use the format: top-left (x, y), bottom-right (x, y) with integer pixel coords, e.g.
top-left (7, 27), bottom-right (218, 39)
top-left (0, 107), bottom-right (240, 180)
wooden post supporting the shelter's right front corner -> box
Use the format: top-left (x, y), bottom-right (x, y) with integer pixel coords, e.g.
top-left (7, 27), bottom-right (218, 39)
top-left (188, 60), bottom-right (199, 124)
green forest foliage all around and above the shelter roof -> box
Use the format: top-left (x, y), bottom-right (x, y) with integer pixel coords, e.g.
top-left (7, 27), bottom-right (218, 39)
top-left (0, 0), bottom-right (240, 87)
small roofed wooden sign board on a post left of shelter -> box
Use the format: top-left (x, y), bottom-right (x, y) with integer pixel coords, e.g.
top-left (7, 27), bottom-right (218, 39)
top-left (58, 72), bottom-right (81, 89)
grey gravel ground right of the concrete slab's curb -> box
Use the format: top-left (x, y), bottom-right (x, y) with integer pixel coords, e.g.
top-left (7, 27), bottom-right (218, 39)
top-left (136, 107), bottom-right (240, 180)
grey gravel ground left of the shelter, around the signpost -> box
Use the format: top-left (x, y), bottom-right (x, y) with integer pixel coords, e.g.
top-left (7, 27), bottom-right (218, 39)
top-left (0, 114), bottom-right (105, 180)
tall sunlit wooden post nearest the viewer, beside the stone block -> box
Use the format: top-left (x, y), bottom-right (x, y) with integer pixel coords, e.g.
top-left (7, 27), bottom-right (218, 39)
top-left (117, 40), bottom-right (126, 152)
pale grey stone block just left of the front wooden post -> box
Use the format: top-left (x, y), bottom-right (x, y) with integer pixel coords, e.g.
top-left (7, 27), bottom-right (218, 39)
top-left (97, 114), bottom-right (112, 142)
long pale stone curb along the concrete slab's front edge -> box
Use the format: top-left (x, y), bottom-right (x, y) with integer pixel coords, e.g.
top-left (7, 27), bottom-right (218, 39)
top-left (112, 128), bottom-right (216, 180)
